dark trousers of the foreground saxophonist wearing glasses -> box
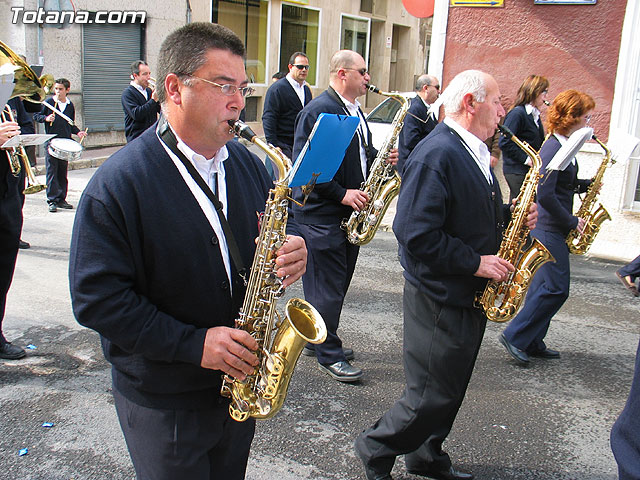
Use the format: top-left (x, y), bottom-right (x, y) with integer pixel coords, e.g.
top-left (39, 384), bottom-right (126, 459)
top-left (113, 388), bottom-right (255, 480)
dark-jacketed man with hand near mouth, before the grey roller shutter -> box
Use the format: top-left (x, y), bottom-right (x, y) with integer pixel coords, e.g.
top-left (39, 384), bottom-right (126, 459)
top-left (121, 60), bottom-right (160, 143)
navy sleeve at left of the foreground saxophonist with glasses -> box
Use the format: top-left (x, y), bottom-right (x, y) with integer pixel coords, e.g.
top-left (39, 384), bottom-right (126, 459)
top-left (69, 186), bottom-right (206, 365)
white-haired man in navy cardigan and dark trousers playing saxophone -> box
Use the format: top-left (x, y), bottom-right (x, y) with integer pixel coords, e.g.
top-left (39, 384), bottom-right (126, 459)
top-left (355, 70), bottom-right (537, 480)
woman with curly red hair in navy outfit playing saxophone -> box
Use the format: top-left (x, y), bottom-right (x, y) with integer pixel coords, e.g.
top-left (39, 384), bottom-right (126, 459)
top-left (500, 90), bottom-right (595, 364)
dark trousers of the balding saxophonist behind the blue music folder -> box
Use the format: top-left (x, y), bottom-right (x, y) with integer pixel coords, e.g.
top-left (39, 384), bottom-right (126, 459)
top-left (300, 224), bottom-right (360, 364)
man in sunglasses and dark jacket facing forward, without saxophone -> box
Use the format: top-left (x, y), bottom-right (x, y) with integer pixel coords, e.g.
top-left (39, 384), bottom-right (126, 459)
top-left (262, 52), bottom-right (311, 160)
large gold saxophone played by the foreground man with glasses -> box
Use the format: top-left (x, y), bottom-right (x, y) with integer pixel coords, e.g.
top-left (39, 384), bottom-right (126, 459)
top-left (220, 121), bottom-right (327, 422)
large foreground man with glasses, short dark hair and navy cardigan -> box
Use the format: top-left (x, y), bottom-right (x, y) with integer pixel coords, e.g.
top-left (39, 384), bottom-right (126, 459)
top-left (69, 23), bottom-right (306, 480)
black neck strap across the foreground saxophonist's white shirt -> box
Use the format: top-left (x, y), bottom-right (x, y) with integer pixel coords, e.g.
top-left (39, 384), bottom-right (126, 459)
top-left (157, 117), bottom-right (247, 286)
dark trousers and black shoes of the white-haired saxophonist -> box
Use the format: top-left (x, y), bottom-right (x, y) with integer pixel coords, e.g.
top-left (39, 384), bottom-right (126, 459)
top-left (356, 282), bottom-right (487, 472)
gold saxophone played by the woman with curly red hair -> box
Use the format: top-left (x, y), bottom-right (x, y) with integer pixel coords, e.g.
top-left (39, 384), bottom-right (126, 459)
top-left (567, 135), bottom-right (616, 255)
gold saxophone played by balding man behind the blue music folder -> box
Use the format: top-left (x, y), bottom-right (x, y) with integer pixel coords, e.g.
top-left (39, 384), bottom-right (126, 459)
top-left (342, 85), bottom-right (409, 245)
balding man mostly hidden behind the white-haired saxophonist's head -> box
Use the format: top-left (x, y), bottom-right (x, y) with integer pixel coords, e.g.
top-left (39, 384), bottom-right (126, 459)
top-left (398, 75), bottom-right (440, 173)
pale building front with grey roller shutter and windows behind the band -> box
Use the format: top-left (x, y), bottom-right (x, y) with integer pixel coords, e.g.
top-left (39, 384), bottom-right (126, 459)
top-left (5, 0), bottom-right (430, 147)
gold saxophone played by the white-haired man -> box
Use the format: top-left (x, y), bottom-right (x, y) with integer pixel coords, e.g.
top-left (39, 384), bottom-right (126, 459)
top-left (478, 125), bottom-right (555, 322)
